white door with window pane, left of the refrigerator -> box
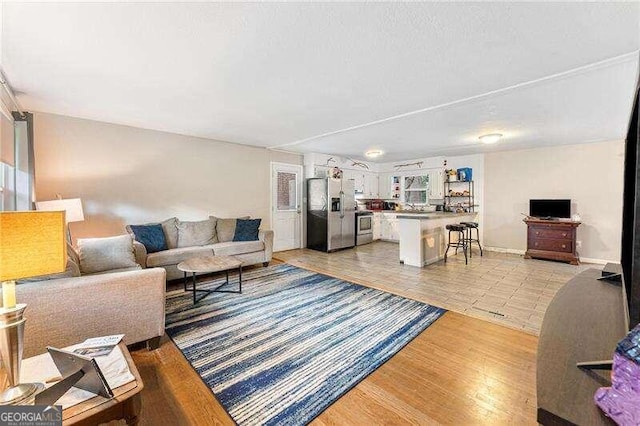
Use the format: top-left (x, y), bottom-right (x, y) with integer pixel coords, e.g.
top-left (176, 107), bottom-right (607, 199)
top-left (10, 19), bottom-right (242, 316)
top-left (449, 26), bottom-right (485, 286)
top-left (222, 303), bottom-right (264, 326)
top-left (271, 163), bottom-right (302, 251)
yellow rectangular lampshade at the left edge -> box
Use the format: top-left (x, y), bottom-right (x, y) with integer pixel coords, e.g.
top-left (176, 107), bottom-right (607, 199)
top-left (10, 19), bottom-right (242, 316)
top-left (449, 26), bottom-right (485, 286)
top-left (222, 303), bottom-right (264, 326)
top-left (0, 211), bottom-right (67, 281)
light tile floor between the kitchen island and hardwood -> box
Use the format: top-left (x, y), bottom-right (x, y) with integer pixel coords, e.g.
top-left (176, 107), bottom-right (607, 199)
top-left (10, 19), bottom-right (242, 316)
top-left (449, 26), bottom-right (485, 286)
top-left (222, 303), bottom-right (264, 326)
top-left (274, 241), bottom-right (602, 335)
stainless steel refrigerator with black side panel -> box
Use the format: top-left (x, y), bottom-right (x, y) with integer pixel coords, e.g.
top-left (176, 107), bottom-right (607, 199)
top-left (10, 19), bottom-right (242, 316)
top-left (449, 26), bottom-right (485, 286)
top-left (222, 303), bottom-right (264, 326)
top-left (307, 178), bottom-right (356, 252)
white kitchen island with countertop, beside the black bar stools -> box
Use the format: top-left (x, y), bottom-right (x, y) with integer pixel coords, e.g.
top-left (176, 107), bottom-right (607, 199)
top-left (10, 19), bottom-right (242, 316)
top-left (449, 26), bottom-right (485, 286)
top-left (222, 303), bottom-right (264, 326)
top-left (397, 212), bottom-right (478, 267)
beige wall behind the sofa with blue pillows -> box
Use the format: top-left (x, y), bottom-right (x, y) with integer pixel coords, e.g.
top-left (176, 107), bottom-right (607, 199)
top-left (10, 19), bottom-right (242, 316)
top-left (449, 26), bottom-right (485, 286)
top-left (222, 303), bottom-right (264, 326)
top-left (34, 113), bottom-right (302, 237)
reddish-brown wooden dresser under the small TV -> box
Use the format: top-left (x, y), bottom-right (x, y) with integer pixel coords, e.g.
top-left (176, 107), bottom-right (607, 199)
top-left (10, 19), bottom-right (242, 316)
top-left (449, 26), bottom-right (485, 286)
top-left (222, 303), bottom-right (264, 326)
top-left (524, 218), bottom-right (580, 265)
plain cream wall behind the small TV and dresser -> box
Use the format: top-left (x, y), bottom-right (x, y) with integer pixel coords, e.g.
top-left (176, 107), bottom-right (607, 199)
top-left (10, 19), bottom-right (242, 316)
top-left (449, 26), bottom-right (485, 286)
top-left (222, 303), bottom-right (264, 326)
top-left (483, 141), bottom-right (624, 262)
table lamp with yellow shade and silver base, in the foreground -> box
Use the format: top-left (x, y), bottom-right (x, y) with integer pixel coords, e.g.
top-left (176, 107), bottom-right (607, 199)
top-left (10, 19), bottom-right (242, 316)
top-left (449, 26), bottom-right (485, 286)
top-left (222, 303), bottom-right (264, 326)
top-left (0, 211), bottom-right (67, 405)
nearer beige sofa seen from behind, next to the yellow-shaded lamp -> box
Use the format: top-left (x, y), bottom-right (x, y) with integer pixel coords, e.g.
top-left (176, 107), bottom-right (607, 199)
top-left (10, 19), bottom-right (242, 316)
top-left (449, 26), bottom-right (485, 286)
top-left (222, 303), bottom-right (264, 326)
top-left (16, 241), bottom-right (166, 358)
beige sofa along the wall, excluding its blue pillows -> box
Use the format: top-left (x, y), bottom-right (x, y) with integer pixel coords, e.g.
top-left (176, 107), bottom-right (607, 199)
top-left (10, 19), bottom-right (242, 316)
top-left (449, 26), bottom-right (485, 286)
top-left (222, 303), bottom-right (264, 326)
top-left (127, 216), bottom-right (273, 280)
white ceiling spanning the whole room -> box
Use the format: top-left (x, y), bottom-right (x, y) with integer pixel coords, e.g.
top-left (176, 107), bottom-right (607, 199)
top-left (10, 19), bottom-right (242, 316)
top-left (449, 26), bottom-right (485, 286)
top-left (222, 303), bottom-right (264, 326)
top-left (1, 2), bottom-right (640, 161)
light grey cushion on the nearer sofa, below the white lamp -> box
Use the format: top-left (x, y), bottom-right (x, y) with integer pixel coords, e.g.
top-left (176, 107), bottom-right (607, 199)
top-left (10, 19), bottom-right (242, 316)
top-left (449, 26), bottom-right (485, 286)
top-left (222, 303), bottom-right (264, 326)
top-left (78, 235), bottom-right (138, 274)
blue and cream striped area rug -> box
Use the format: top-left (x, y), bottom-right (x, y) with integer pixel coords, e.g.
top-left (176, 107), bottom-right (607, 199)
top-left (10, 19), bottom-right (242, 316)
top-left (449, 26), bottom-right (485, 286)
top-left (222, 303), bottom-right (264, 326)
top-left (166, 264), bottom-right (445, 425)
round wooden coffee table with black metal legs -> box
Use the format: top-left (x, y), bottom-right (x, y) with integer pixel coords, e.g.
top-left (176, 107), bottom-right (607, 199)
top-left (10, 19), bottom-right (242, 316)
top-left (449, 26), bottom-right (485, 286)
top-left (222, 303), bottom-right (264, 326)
top-left (177, 256), bottom-right (242, 304)
